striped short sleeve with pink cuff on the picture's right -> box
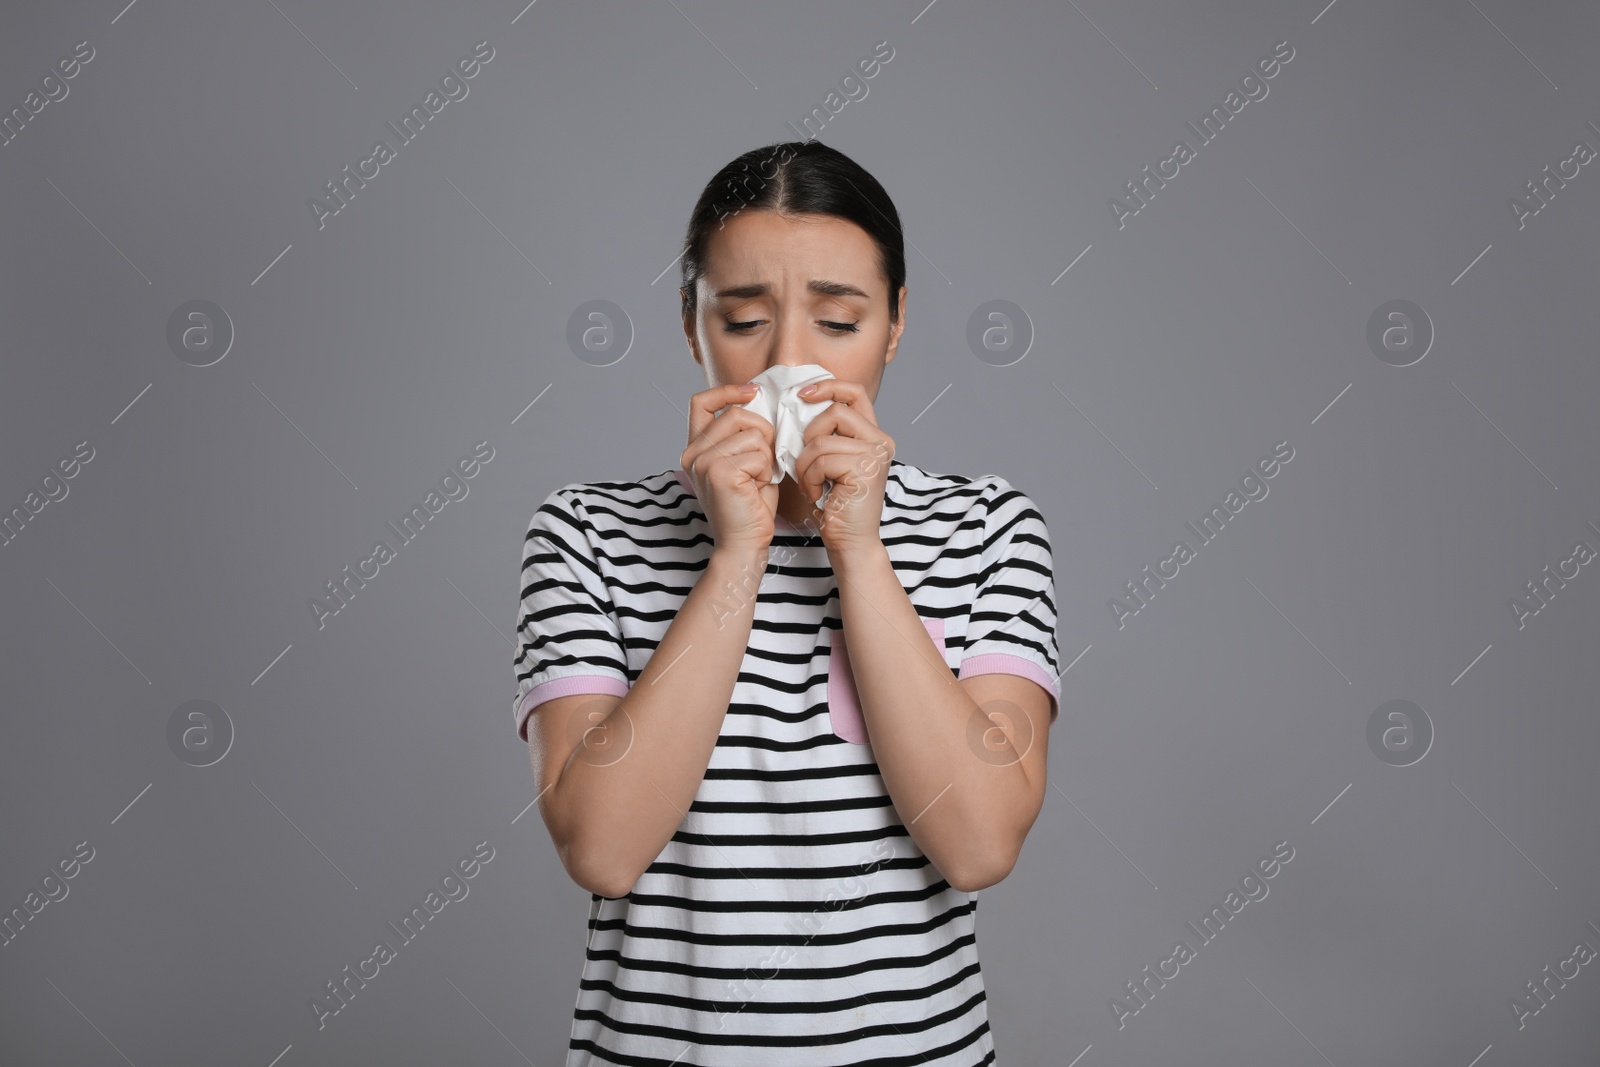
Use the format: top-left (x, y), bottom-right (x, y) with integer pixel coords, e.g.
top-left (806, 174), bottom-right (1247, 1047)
top-left (957, 475), bottom-right (1061, 723)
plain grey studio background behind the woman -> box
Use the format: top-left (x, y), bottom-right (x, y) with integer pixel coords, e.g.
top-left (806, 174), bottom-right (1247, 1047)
top-left (0, 0), bottom-right (1600, 1067)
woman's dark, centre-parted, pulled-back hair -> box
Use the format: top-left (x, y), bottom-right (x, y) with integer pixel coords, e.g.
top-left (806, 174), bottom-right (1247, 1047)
top-left (682, 141), bottom-right (906, 323)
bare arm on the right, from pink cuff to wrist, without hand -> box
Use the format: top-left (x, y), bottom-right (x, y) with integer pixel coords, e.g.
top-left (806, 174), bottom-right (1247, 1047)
top-left (829, 542), bottom-right (1050, 893)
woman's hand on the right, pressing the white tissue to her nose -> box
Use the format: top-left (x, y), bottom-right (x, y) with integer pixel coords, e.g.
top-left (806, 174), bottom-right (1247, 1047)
top-left (795, 378), bottom-right (894, 555)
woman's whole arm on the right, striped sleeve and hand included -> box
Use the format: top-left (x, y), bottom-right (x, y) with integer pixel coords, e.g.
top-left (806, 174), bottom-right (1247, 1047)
top-left (777, 379), bottom-right (1054, 893)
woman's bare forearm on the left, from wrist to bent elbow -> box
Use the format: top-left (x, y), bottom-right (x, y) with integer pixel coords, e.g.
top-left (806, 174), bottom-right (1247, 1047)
top-left (552, 547), bottom-right (768, 897)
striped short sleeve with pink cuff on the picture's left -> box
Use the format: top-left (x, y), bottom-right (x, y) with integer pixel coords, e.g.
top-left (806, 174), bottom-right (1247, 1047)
top-left (512, 485), bottom-right (629, 742)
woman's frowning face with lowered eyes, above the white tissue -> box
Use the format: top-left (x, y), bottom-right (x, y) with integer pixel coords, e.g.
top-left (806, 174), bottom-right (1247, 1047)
top-left (683, 211), bottom-right (906, 402)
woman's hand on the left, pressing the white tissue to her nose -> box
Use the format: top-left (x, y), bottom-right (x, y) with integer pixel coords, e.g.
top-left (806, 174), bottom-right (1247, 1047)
top-left (678, 382), bottom-right (778, 552)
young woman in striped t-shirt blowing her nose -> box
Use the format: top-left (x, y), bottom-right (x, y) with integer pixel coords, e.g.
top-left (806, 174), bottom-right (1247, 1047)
top-left (514, 141), bottom-right (1061, 1067)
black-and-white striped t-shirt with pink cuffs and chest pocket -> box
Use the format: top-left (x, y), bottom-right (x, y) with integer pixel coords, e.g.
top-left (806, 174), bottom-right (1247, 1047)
top-left (512, 459), bottom-right (1061, 1067)
